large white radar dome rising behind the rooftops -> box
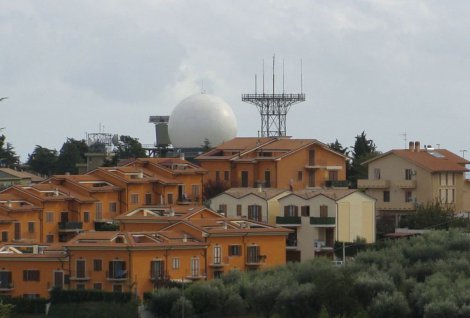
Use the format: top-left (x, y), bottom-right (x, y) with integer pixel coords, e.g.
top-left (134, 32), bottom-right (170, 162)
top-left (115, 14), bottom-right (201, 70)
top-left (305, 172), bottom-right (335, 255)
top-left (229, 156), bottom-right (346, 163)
top-left (168, 94), bottom-right (237, 148)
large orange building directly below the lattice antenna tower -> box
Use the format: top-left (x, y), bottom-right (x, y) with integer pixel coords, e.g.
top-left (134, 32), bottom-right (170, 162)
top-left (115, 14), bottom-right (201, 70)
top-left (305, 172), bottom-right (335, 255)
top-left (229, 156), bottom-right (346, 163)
top-left (196, 137), bottom-right (347, 190)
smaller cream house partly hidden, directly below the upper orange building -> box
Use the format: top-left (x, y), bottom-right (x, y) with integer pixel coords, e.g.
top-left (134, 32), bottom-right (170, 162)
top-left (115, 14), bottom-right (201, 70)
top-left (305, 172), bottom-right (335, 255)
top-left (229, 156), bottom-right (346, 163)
top-left (210, 188), bottom-right (290, 224)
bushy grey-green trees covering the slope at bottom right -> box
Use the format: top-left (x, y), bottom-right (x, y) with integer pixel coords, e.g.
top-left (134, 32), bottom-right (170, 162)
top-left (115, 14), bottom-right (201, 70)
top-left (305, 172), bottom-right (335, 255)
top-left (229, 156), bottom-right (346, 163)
top-left (147, 230), bottom-right (470, 318)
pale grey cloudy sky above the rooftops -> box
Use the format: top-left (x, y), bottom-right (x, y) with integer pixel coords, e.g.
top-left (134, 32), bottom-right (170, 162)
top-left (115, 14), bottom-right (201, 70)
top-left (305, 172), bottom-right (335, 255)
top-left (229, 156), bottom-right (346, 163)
top-left (0, 0), bottom-right (470, 162)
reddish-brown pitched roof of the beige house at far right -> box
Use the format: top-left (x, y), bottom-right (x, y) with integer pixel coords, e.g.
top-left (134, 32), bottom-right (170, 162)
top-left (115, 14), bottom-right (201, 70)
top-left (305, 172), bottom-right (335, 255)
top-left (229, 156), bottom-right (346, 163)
top-left (363, 149), bottom-right (470, 172)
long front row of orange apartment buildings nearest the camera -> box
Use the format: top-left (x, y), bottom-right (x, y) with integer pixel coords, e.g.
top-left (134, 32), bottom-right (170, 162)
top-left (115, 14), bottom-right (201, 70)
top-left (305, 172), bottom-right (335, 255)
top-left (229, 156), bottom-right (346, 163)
top-left (0, 208), bottom-right (290, 297)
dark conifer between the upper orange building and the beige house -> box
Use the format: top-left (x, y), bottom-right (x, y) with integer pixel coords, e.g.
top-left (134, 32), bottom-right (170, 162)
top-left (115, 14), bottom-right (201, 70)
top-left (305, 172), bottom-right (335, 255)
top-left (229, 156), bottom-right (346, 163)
top-left (348, 131), bottom-right (380, 188)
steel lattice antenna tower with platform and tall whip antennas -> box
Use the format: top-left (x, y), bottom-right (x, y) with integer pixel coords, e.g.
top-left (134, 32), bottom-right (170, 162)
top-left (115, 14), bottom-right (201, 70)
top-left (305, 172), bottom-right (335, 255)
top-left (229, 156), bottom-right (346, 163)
top-left (242, 56), bottom-right (305, 137)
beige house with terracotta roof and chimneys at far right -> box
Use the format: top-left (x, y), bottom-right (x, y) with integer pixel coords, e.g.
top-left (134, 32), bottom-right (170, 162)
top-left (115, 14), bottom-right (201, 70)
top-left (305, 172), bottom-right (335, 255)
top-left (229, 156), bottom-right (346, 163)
top-left (358, 142), bottom-right (470, 221)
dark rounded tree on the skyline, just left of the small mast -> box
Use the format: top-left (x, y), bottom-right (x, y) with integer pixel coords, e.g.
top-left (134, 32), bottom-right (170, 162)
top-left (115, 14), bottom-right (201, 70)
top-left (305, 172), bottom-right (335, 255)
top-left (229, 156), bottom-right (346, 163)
top-left (55, 138), bottom-right (88, 174)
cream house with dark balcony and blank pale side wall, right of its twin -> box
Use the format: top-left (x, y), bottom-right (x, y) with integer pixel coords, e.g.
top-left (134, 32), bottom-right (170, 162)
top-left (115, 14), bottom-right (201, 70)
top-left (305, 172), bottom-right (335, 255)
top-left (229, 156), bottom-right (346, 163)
top-left (276, 189), bottom-right (375, 261)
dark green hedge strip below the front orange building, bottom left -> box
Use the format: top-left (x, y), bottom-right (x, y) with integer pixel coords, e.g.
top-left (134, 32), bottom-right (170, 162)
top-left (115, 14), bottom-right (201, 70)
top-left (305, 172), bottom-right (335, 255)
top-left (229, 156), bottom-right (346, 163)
top-left (50, 288), bottom-right (132, 304)
